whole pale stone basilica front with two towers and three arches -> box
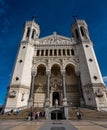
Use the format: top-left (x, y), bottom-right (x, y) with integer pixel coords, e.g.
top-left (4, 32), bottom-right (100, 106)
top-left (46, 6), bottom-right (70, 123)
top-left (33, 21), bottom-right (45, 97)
top-left (5, 19), bottom-right (107, 118)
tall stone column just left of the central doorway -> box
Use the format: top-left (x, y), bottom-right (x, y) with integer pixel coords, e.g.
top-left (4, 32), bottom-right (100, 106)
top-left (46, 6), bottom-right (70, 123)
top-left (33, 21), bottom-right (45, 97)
top-left (45, 70), bottom-right (51, 119)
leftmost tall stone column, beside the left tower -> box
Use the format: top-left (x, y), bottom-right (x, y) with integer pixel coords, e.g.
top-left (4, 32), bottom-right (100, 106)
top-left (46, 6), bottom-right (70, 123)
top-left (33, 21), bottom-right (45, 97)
top-left (28, 70), bottom-right (36, 107)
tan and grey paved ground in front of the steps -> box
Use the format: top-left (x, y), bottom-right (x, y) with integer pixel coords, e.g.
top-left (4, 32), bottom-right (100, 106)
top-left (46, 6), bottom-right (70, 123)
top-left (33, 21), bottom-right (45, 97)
top-left (0, 120), bottom-right (107, 130)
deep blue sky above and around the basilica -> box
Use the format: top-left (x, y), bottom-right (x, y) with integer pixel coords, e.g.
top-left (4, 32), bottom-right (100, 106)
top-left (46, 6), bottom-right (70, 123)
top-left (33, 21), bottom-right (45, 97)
top-left (0, 0), bottom-right (107, 104)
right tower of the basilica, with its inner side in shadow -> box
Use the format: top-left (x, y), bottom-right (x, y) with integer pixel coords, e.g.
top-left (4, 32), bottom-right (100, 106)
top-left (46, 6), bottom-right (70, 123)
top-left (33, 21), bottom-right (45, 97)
top-left (71, 18), bottom-right (107, 110)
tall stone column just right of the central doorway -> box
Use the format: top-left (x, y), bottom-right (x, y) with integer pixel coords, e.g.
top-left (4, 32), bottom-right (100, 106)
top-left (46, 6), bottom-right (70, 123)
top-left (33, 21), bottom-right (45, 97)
top-left (61, 70), bottom-right (68, 119)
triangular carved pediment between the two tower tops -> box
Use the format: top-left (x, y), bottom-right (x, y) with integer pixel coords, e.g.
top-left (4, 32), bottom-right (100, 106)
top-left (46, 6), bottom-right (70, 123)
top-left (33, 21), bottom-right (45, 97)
top-left (36, 32), bottom-right (74, 45)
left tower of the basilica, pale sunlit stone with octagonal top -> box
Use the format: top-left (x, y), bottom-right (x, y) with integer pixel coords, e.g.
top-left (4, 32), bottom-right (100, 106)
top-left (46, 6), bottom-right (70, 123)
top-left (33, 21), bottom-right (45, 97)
top-left (5, 19), bottom-right (40, 112)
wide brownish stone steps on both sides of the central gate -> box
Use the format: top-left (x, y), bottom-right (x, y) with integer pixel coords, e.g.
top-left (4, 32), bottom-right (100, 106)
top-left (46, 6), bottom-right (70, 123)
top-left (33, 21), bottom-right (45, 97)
top-left (0, 107), bottom-right (107, 120)
